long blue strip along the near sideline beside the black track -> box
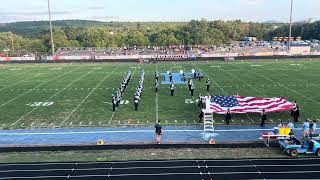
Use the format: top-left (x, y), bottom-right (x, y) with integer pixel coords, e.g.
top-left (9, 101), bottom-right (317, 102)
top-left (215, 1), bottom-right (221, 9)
top-left (0, 126), bottom-right (301, 146)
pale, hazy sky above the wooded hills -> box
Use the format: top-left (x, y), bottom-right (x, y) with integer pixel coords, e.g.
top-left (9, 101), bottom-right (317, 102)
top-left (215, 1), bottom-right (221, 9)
top-left (0, 0), bottom-right (320, 23)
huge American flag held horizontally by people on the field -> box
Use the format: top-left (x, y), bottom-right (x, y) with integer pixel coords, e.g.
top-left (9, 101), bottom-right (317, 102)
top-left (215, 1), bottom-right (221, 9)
top-left (210, 96), bottom-right (294, 114)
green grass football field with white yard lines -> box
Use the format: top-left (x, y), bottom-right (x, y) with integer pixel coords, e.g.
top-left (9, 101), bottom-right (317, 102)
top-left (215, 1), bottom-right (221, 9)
top-left (0, 60), bottom-right (320, 129)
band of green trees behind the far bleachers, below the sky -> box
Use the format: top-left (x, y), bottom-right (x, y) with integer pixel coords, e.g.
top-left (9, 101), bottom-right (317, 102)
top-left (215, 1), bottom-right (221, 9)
top-left (0, 19), bottom-right (320, 55)
